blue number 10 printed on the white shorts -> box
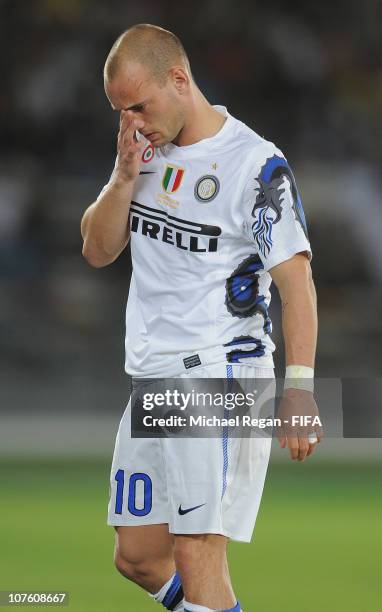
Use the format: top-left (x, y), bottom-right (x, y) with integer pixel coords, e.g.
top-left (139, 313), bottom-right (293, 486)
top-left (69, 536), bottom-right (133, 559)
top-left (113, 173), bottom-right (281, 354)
top-left (115, 470), bottom-right (153, 516)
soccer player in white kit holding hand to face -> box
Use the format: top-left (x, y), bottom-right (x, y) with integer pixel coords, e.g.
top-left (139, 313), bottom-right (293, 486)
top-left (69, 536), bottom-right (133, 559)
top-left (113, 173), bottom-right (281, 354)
top-left (81, 24), bottom-right (319, 612)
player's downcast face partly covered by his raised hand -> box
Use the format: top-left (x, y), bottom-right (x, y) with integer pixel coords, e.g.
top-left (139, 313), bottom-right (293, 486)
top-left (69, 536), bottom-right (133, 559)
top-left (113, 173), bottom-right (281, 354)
top-left (105, 64), bottom-right (185, 147)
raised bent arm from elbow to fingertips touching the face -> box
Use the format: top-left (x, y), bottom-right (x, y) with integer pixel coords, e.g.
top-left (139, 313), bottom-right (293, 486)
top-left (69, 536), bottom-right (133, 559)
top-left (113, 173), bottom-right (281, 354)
top-left (81, 111), bottom-right (142, 268)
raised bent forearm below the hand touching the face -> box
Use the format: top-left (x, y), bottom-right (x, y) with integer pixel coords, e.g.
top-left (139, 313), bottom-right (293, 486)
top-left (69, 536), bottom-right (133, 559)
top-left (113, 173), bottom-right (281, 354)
top-left (81, 180), bottom-right (134, 267)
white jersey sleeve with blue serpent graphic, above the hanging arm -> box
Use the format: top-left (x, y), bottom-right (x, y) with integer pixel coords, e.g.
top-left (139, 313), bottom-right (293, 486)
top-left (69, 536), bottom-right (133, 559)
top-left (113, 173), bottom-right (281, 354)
top-left (243, 145), bottom-right (312, 270)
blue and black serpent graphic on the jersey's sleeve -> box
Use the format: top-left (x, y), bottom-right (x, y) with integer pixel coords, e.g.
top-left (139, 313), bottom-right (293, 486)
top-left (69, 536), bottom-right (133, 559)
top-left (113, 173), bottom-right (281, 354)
top-left (252, 155), bottom-right (307, 257)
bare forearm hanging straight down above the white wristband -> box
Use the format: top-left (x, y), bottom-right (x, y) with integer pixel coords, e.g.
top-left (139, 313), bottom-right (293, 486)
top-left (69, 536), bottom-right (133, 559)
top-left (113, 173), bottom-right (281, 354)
top-left (280, 270), bottom-right (317, 368)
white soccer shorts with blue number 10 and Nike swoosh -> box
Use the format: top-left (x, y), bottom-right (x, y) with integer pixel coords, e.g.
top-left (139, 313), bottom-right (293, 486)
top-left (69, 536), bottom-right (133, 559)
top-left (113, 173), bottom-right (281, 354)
top-left (108, 362), bottom-right (275, 542)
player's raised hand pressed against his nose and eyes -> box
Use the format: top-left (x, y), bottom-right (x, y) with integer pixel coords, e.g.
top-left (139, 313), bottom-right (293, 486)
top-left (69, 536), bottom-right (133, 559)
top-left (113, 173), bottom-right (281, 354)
top-left (114, 110), bottom-right (144, 182)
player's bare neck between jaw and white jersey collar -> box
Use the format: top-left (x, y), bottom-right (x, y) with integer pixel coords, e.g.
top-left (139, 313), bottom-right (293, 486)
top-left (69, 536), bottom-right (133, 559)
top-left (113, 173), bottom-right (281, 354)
top-left (172, 87), bottom-right (226, 147)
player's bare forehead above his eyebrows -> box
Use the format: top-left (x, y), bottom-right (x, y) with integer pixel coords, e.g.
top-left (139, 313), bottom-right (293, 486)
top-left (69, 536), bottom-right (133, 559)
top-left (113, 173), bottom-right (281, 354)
top-left (105, 64), bottom-right (155, 108)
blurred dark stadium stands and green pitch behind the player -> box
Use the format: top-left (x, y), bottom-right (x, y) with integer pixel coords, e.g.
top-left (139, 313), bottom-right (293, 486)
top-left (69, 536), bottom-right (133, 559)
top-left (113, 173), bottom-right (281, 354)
top-left (0, 0), bottom-right (382, 612)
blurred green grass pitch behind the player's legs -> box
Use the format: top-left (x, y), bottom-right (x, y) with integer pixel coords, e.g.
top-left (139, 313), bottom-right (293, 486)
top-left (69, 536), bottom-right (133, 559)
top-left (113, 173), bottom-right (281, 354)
top-left (0, 459), bottom-right (382, 612)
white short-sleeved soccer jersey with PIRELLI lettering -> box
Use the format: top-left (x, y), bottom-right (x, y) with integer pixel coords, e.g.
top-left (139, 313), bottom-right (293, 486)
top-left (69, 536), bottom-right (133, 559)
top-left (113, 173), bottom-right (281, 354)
top-left (100, 106), bottom-right (310, 377)
